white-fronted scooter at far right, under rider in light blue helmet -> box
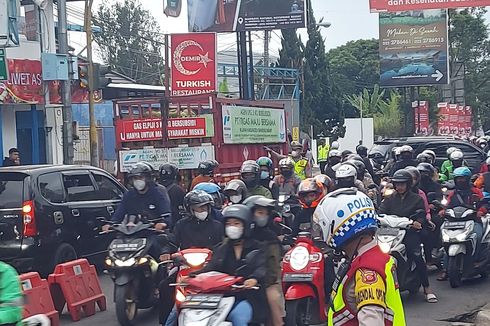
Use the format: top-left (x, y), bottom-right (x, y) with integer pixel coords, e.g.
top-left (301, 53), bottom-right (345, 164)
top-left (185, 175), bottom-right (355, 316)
top-left (441, 207), bottom-right (490, 288)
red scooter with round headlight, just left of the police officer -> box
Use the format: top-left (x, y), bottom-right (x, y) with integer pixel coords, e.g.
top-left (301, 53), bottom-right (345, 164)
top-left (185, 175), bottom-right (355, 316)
top-left (282, 232), bottom-right (334, 326)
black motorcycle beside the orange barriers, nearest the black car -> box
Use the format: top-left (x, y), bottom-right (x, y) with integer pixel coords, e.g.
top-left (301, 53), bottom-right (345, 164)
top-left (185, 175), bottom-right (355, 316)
top-left (105, 215), bottom-right (167, 326)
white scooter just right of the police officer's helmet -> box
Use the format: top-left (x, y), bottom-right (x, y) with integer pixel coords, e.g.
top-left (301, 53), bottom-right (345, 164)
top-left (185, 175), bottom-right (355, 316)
top-left (376, 214), bottom-right (423, 293)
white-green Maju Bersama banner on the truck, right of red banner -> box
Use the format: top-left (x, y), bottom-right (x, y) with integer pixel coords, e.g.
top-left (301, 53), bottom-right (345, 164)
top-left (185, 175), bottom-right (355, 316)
top-left (222, 105), bottom-right (287, 144)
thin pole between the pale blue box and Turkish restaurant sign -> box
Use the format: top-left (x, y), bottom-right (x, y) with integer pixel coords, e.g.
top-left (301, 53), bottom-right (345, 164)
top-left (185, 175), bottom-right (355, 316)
top-left (84, 0), bottom-right (99, 167)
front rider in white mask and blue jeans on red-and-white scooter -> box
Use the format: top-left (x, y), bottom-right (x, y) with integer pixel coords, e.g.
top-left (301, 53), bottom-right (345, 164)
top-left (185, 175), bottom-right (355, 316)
top-left (194, 204), bottom-right (267, 326)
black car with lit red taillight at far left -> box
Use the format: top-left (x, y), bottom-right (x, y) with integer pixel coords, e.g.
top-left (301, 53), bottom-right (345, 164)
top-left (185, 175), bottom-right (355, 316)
top-left (0, 165), bottom-right (126, 275)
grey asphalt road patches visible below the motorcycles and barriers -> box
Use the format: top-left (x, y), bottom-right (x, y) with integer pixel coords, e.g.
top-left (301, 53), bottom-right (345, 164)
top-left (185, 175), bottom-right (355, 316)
top-left (61, 275), bottom-right (490, 326)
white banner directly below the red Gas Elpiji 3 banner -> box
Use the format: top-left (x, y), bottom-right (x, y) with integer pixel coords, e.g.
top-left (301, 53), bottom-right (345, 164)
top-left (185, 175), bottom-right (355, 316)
top-left (119, 145), bottom-right (215, 172)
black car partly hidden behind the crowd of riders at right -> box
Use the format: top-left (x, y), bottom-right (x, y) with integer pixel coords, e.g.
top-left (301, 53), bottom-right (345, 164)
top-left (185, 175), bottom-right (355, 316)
top-left (369, 136), bottom-right (486, 173)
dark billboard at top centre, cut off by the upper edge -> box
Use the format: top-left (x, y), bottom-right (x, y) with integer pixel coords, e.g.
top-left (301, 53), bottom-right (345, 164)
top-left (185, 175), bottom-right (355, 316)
top-left (187, 0), bottom-right (306, 32)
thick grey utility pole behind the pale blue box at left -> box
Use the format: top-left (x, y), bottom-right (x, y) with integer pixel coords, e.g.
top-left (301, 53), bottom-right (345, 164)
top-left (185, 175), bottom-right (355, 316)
top-left (58, 0), bottom-right (73, 164)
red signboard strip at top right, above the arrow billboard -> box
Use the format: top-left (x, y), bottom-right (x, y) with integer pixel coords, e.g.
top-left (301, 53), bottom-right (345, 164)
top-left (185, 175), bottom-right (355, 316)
top-left (369, 0), bottom-right (490, 12)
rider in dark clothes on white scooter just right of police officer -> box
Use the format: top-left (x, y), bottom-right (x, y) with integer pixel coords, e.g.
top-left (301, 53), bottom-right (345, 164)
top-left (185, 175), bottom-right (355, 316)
top-left (379, 170), bottom-right (437, 303)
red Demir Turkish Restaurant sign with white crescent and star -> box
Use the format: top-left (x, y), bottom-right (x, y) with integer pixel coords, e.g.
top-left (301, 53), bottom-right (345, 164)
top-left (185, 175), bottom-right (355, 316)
top-left (171, 33), bottom-right (217, 96)
